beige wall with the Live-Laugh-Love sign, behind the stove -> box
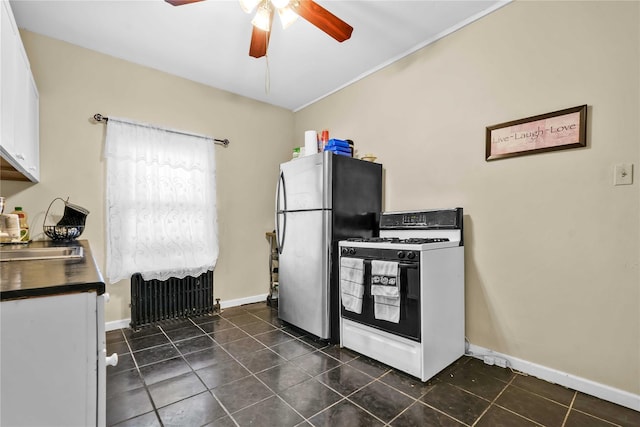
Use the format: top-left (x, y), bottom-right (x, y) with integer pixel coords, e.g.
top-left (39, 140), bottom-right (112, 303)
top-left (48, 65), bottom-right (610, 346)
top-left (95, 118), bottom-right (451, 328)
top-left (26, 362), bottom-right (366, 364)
top-left (295, 2), bottom-right (640, 394)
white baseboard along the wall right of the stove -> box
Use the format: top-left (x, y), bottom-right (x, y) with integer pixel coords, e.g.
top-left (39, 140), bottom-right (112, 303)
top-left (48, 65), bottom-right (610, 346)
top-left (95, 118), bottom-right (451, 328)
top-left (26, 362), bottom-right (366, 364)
top-left (467, 344), bottom-right (640, 411)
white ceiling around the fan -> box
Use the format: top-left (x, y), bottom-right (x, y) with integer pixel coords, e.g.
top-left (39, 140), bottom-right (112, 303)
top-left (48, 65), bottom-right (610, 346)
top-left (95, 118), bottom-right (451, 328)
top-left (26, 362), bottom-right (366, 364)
top-left (10, 0), bottom-right (508, 111)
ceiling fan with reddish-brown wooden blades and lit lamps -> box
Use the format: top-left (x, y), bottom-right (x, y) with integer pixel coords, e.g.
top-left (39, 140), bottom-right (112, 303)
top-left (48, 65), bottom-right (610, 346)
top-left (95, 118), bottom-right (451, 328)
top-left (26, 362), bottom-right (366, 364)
top-left (165, 0), bottom-right (353, 58)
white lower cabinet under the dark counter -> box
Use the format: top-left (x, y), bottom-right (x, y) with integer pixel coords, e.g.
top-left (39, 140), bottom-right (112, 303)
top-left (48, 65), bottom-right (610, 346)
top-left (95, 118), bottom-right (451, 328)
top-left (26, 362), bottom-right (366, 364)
top-left (0, 292), bottom-right (106, 427)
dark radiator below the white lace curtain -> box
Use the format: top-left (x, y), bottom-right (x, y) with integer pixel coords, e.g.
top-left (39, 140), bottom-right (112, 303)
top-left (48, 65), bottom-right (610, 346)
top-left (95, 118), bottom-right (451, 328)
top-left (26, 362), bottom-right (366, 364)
top-left (131, 271), bottom-right (216, 329)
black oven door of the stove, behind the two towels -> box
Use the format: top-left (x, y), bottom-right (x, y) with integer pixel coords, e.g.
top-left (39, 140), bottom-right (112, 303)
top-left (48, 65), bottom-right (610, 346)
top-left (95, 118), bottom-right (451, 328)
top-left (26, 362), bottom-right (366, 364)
top-left (340, 259), bottom-right (421, 342)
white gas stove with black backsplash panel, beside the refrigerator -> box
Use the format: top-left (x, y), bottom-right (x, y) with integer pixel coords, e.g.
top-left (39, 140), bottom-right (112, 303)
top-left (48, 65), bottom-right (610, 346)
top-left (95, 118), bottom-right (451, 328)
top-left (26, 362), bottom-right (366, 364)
top-left (339, 208), bottom-right (464, 381)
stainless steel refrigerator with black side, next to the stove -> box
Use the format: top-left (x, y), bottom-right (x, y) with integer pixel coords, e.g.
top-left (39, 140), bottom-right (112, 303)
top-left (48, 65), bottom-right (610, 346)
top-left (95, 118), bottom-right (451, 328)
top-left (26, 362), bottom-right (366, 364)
top-left (276, 151), bottom-right (382, 342)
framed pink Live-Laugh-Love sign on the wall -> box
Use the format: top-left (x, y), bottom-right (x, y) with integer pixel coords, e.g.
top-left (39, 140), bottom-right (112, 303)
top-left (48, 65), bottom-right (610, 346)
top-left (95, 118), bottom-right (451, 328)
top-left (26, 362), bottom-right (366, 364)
top-left (486, 105), bottom-right (587, 160)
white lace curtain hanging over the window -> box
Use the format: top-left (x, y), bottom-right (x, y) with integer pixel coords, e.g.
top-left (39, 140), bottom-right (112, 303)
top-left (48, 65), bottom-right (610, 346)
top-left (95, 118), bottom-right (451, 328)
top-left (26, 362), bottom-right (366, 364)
top-left (105, 118), bottom-right (218, 283)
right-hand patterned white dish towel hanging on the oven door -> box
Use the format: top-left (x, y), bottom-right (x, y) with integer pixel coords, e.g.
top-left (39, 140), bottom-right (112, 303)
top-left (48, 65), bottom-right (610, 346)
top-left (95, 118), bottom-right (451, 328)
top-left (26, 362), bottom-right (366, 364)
top-left (371, 260), bottom-right (400, 323)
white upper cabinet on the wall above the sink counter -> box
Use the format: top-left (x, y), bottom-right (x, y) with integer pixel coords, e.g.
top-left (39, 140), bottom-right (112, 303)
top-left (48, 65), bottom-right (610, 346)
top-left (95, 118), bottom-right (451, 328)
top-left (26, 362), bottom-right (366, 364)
top-left (0, 0), bottom-right (40, 182)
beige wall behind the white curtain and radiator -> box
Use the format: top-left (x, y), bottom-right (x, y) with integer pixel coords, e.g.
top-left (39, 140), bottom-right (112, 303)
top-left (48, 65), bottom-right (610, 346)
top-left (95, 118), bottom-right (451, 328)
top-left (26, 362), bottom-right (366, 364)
top-left (1, 32), bottom-right (293, 321)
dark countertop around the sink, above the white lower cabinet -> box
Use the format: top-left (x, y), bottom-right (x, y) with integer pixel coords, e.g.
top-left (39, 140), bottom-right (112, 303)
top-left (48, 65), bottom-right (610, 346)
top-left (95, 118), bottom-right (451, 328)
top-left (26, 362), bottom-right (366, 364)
top-left (0, 240), bottom-right (105, 301)
